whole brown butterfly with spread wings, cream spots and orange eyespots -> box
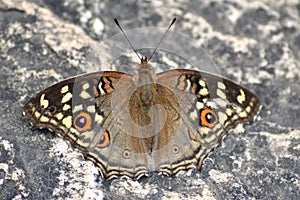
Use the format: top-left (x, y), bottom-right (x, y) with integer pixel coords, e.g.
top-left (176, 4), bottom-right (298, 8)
top-left (24, 18), bottom-right (261, 179)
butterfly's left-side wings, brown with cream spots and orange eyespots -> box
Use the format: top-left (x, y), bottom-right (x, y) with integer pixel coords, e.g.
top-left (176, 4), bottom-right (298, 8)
top-left (24, 72), bottom-right (149, 178)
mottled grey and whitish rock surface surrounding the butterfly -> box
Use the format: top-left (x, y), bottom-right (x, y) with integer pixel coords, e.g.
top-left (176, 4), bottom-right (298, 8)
top-left (0, 0), bottom-right (300, 199)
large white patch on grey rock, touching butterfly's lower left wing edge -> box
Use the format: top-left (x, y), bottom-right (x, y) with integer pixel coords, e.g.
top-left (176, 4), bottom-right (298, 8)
top-left (50, 138), bottom-right (104, 199)
